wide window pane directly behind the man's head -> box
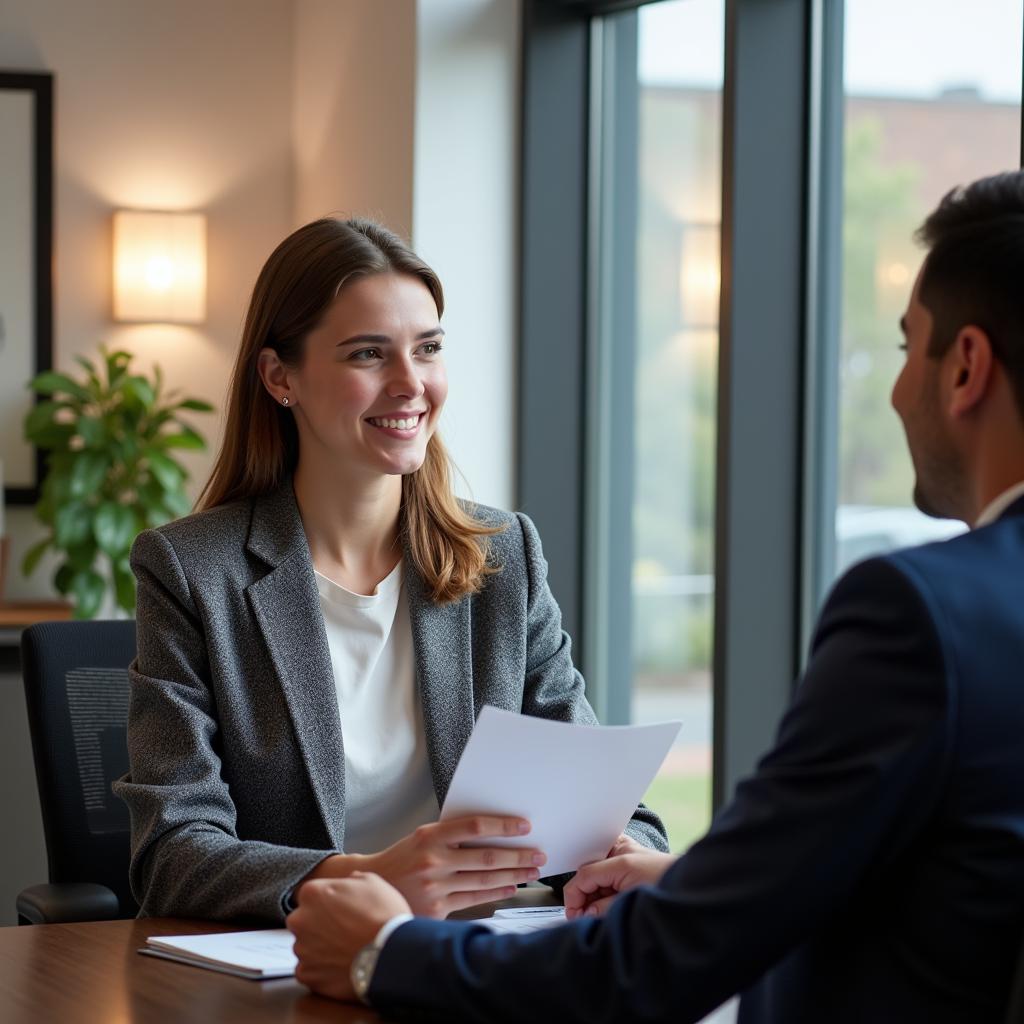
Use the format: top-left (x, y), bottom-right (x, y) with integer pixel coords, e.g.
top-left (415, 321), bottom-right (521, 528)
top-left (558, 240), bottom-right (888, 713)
top-left (835, 0), bottom-right (1024, 572)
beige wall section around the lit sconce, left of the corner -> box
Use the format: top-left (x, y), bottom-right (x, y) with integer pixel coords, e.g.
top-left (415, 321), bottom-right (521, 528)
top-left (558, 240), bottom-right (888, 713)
top-left (0, 0), bottom-right (294, 598)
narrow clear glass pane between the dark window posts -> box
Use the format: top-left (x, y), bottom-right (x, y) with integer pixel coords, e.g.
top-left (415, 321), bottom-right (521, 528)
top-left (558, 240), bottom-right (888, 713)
top-left (632, 0), bottom-right (724, 850)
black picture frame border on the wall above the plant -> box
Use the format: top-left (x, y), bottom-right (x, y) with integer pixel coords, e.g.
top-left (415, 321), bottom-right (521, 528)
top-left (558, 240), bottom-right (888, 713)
top-left (0, 71), bottom-right (53, 505)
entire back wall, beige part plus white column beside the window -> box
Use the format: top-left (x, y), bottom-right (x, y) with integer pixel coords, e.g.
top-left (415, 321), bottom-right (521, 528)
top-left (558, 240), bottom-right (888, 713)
top-left (0, 0), bottom-right (519, 599)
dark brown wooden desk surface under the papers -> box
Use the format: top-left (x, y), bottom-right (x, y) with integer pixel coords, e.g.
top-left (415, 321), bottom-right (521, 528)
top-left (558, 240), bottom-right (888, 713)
top-left (0, 889), bottom-right (552, 1024)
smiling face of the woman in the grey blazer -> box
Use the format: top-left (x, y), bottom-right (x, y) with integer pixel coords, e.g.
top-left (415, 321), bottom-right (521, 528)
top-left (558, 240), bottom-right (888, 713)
top-left (275, 273), bottom-right (447, 475)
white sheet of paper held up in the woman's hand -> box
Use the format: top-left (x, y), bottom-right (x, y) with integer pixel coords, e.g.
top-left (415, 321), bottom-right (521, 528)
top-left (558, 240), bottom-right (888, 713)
top-left (440, 706), bottom-right (680, 874)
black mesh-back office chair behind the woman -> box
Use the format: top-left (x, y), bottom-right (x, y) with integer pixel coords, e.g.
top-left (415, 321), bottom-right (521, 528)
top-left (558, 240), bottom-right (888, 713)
top-left (17, 621), bottom-right (138, 925)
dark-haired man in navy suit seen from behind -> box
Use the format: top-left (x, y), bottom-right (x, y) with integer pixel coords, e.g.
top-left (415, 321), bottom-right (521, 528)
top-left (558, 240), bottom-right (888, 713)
top-left (289, 173), bottom-right (1024, 1024)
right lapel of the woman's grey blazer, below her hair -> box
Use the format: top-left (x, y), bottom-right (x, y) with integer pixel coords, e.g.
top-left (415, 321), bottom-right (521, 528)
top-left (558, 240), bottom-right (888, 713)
top-left (406, 561), bottom-right (476, 806)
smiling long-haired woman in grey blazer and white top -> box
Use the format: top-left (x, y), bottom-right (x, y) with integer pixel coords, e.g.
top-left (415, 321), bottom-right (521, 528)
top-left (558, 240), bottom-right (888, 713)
top-left (116, 220), bottom-right (667, 922)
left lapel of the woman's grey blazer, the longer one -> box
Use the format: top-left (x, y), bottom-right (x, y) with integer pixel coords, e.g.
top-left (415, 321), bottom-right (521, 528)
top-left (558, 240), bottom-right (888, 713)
top-left (247, 486), bottom-right (345, 850)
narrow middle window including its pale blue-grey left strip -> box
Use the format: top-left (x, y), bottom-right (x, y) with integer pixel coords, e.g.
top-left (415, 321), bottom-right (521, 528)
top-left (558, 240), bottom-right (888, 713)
top-left (585, 0), bottom-right (724, 850)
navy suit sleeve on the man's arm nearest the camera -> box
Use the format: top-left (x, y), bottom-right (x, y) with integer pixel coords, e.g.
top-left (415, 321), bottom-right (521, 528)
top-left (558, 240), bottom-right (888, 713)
top-left (370, 560), bottom-right (952, 1022)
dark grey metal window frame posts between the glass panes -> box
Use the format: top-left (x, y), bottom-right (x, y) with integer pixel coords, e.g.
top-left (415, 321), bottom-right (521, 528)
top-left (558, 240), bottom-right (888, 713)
top-left (516, 0), bottom-right (1024, 807)
